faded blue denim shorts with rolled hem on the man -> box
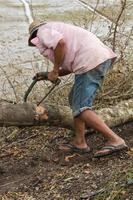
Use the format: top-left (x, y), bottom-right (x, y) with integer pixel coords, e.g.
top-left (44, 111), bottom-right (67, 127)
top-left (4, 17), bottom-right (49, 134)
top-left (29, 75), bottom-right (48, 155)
top-left (69, 59), bottom-right (112, 117)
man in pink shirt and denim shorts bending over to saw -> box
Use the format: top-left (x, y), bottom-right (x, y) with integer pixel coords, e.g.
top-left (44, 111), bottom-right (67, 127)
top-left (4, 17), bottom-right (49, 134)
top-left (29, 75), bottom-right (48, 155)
top-left (28, 22), bottom-right (127, 157)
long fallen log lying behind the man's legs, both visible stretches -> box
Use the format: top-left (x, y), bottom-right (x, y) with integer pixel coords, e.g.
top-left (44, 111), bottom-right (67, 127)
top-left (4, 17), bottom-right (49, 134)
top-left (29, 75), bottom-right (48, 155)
top-left (0, 99), bottom-right (133, 129)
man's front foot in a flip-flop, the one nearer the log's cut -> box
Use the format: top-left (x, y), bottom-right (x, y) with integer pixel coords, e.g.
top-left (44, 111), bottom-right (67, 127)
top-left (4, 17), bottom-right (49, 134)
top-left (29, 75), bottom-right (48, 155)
top-left (59, 143), bottom-right (91, 154)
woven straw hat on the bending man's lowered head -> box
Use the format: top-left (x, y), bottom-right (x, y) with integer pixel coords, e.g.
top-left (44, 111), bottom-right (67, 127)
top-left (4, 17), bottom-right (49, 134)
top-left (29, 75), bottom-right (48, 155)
top-left (28, 20), bottom-right (46, 46)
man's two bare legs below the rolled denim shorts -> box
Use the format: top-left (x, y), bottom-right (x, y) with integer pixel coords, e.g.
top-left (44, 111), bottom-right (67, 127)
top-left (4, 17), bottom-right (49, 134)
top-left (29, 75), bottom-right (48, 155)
top-left (59, 109), bottom-right (125, 152)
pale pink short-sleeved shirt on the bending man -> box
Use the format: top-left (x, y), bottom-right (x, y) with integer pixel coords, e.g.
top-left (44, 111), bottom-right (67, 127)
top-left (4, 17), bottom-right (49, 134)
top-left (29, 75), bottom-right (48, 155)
top-left (31, 22), bottom-right (116, 74)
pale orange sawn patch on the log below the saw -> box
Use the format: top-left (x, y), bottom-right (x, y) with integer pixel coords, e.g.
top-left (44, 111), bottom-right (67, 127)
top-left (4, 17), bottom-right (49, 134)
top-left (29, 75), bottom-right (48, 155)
top-left (36, 106), bottom-right (48, 120)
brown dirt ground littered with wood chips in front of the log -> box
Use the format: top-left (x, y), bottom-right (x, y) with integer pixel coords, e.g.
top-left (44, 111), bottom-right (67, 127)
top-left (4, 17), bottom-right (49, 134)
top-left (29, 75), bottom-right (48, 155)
top-left (0, 122), bottom-right (133, 200)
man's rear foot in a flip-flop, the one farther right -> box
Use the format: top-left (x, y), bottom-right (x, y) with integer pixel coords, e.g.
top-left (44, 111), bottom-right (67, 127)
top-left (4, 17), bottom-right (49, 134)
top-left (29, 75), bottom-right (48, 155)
top-left (94, 143), bottom-right (128, 158)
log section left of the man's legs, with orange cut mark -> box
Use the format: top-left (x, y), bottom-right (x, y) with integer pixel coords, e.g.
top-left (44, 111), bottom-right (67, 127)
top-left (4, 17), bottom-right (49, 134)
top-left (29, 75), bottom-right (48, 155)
top-left (0, 103), bottom-right (73, 129)
